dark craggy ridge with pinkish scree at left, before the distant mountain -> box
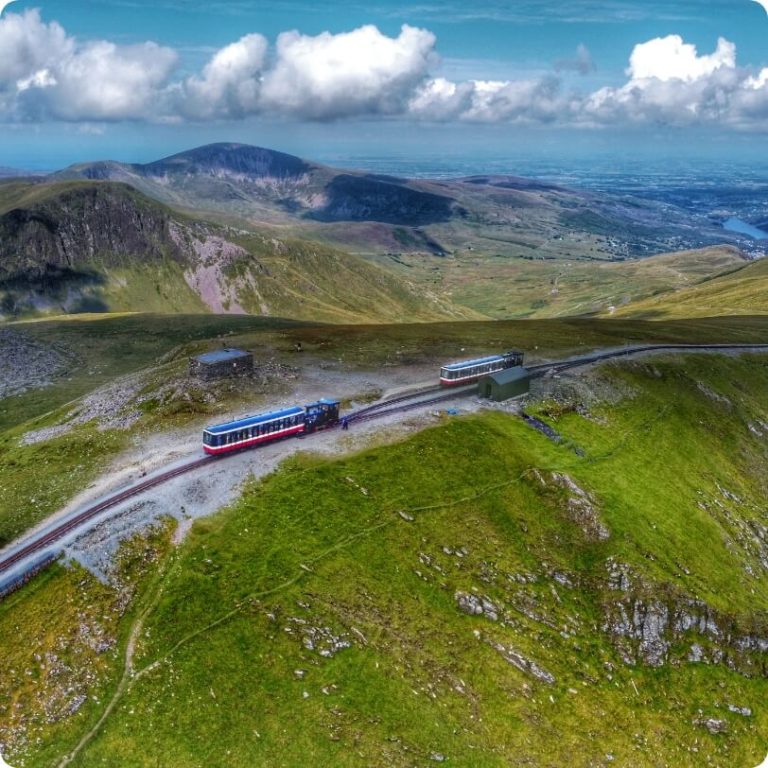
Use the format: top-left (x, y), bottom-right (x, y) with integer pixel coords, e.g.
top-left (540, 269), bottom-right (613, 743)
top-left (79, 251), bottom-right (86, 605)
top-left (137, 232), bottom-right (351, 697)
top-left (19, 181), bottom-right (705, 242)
top-left (0, 180), bottom-right (464, 322)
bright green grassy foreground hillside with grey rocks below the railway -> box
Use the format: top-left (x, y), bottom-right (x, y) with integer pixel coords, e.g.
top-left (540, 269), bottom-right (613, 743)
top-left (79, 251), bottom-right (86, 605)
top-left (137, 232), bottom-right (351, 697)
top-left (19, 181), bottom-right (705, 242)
top-left (0, 356), bottom-right (768, 768)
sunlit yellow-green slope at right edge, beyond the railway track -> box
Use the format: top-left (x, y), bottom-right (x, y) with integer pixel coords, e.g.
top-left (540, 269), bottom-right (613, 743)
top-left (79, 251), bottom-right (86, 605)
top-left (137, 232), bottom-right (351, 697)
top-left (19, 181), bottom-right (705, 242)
top-left (616, 259), bottom-right (768, 320)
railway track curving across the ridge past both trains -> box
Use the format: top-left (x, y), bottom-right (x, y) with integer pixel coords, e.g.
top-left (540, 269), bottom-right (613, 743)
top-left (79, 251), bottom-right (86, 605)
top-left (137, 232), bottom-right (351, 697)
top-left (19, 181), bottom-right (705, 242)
top-left (0, 344), bottom-right (768, 598)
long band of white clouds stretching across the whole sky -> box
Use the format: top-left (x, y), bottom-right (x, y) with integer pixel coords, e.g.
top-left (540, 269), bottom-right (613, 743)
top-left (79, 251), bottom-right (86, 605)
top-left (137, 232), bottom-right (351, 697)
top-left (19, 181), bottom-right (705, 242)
top-left (0, 10), bottom-right (768, 129)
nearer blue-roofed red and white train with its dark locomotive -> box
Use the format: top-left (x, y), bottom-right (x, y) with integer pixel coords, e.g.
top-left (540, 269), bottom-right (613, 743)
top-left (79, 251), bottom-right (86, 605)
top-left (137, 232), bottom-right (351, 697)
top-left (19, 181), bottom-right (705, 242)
top-left (203, 398), bottom-right (340, 456)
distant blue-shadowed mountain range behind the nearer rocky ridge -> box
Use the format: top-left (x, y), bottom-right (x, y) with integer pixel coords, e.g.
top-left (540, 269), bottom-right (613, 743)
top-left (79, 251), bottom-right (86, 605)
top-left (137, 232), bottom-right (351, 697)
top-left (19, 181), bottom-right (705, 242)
top-left (50, 144), bottom-right (733, 259)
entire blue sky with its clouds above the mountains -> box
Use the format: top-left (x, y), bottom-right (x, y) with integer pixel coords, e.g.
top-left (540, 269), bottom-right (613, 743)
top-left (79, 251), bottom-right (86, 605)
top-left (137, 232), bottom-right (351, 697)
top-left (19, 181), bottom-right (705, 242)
top-left (0, 0), bottom-right (768, 168)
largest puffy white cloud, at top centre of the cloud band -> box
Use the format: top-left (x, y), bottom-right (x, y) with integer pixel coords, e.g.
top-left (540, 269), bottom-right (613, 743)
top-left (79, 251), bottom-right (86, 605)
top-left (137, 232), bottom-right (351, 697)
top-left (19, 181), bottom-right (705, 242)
top-left (262, 24), bottom-right (435, 120)
